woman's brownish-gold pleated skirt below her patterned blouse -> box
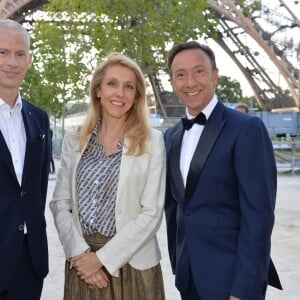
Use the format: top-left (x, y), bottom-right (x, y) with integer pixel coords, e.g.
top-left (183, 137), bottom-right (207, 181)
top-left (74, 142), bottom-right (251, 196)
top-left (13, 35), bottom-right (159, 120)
top-left (64, 233), bottom-right (165, 300)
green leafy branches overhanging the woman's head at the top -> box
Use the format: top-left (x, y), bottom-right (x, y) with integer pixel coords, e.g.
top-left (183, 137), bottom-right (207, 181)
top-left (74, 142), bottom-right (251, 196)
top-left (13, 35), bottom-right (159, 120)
top-left (48, 0), bottom-right (216, 74)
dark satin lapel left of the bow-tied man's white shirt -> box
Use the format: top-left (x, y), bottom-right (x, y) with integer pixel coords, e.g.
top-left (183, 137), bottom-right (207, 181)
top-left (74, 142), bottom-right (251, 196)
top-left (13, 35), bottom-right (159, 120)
top-left (168, 126), bottom-right (184, 199)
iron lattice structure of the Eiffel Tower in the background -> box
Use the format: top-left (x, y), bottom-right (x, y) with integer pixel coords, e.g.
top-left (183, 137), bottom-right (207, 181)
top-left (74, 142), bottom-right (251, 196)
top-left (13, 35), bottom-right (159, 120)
top-left (0, 0), bottom-right (300, 112)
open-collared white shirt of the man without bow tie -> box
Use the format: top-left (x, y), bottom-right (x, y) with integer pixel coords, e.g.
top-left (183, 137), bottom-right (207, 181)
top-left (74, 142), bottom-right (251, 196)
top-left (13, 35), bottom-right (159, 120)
top-left (0, 94), bottom-right (27, 233)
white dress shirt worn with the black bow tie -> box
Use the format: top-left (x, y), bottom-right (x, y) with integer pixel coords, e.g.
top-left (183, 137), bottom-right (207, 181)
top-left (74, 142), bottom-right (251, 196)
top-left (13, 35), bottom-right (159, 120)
top-left (180, 95), bottom-right (218, 186)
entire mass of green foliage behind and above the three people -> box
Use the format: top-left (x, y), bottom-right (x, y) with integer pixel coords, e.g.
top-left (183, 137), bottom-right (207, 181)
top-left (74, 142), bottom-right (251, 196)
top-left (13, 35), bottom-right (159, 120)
top-left (22, 0), bottom-right (217, 122)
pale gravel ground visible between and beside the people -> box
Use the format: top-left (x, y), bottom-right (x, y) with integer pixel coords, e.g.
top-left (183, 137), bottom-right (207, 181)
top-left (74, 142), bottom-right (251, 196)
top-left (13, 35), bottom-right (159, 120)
top-left (42, 171), bottom-right (300, 300)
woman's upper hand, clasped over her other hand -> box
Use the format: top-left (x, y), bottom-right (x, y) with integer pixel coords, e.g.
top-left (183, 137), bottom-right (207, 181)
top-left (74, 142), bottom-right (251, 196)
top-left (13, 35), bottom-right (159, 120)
top-left (69, 252), bottom-right (103, 280)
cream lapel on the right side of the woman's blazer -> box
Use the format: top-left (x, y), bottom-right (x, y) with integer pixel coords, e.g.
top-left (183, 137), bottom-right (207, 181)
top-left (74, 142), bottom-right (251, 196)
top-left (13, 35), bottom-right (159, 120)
top-left (116, 141), bottom-right (135, 205)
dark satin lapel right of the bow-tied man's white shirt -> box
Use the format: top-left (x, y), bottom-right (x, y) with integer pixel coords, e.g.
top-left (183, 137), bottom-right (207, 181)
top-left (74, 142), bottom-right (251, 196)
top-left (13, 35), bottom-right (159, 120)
top-left (184, 102), bottom-right (225, 199)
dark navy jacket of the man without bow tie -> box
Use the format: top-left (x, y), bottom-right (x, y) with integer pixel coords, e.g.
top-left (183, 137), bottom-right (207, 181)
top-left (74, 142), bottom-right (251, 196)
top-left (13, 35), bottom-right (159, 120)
top-left (0, 99), bottom-right (50, 291)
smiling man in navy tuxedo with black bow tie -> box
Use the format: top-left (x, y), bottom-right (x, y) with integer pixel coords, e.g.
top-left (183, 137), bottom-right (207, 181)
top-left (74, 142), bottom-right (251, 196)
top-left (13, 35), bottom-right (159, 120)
top-left (165, 41), bottom-right (281, 300)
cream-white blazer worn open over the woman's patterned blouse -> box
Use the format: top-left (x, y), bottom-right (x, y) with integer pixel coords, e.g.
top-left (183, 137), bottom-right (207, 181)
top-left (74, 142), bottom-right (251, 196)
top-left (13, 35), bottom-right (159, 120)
top-left (50, 129), bottom-right (166, 276)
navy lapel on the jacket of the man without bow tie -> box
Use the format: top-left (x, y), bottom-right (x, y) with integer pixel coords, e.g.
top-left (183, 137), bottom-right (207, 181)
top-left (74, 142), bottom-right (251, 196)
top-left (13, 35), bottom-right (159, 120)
top-left (22, 101), bottom-right (37, 182)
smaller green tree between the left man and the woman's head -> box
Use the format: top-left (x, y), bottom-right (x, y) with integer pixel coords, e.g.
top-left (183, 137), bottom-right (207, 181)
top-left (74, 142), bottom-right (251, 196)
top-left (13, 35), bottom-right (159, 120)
top-left (22, 14), bottom-right (92, 130)
